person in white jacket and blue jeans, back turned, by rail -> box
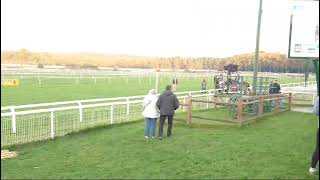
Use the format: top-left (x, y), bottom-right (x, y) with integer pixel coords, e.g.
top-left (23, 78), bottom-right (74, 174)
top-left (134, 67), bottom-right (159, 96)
top-left (142, 89), bottom-right (159, 138)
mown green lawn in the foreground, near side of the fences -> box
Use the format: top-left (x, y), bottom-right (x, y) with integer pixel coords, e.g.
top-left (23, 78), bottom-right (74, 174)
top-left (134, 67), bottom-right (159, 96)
top-left (1, 112), bottom-right (319, 179)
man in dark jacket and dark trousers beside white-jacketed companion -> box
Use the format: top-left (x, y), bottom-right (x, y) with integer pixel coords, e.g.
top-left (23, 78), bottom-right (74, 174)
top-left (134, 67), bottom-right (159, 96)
top-left (157, 85), bottom-right (179, 139)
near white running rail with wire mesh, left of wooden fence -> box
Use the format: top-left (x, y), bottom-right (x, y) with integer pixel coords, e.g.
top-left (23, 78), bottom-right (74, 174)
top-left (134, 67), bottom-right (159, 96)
top-left (1, 90), bottom-right (214, 147)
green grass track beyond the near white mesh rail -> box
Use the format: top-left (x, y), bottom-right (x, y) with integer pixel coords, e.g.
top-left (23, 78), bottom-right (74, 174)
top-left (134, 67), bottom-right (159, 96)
top-left (1, 74), bottom-right (312, 106)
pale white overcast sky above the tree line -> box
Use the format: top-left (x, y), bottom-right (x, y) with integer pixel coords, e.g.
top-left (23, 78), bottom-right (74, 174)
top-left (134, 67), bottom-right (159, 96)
top-left (1, 0), bottom-right (292, 57)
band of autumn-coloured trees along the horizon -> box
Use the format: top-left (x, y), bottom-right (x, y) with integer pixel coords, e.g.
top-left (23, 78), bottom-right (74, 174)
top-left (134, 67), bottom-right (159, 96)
top-left (1, 49), bottom-right (314, 73)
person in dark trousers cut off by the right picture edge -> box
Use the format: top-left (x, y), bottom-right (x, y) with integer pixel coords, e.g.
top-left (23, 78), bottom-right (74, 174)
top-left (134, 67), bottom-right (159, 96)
top-left (309, 96), bottom-right (319, 173)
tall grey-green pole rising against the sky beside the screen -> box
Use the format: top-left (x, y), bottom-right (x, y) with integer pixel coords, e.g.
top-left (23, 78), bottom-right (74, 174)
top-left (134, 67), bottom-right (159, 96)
top-left (252, 0), bottom-right (262, 94)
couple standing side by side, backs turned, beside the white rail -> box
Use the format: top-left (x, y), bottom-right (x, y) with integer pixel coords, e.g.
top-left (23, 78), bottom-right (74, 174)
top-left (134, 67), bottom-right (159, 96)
top-left (142, 85), bottom-right (179, 139)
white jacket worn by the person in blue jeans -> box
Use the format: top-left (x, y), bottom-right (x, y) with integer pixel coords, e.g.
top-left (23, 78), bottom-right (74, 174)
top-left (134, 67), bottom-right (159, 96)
top-left (142, 94), bottom-right (159, 118)
